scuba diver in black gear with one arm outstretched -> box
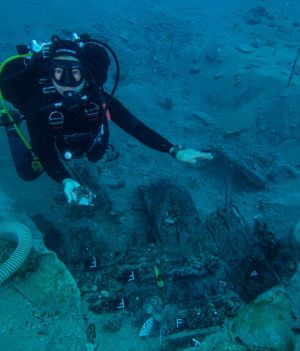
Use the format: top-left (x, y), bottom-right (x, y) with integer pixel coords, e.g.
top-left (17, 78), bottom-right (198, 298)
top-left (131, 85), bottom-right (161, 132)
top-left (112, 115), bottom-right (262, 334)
top-left (0, 33), bottom-right (213, 205)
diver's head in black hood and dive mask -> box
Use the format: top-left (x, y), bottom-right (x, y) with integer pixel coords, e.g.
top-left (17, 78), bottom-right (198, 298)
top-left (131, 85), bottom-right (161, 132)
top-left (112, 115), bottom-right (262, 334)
top-left (50, 40), bottom-right (86, 96)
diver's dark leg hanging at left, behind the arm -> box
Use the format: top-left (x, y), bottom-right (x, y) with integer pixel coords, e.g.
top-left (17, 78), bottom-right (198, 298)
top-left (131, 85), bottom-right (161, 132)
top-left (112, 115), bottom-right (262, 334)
top-left (6, 127), bottom-right (41, 181)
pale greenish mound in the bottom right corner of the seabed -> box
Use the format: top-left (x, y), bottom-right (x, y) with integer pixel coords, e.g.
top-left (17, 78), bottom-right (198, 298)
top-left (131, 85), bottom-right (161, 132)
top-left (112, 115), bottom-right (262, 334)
top-left (201, 286), bottom-right (300, 351)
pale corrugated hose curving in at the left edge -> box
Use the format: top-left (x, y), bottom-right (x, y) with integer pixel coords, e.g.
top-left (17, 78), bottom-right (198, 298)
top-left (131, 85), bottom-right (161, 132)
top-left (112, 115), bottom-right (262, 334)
top-left (0, 222), bottom-right (32, 284)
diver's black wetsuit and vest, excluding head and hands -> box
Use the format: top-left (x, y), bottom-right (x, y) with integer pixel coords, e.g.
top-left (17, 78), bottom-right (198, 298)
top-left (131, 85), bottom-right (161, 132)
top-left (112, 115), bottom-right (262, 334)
top-left (0, 45), bottom-right (172, 182)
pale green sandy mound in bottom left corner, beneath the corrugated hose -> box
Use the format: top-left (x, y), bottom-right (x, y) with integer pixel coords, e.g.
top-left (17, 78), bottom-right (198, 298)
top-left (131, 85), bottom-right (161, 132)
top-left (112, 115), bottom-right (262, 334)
top-left (0, 188), bottom-right (86, 351)
